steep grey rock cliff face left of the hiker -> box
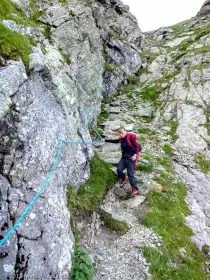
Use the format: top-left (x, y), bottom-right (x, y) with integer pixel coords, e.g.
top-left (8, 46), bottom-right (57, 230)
top-left (0, 0), bottom-right (141, 279)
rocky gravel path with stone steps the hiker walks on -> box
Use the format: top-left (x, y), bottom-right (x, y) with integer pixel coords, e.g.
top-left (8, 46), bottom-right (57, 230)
top-left (77, 91), bottom-right (174, 280)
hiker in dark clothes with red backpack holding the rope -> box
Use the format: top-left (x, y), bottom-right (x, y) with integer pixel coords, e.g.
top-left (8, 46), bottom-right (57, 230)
top-left (102, 127), bottom-right (139, 195)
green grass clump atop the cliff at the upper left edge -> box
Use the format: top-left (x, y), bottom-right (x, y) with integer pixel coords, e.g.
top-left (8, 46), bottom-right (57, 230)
top-left (0, 24), bottom-right (31, 66)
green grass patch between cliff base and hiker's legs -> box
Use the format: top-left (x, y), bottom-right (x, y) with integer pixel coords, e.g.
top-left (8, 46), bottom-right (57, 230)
top-left (67, 154), bottom-right (117, 212)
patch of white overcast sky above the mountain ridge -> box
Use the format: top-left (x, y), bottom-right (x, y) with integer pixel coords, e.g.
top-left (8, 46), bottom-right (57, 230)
top-left (122, 0), bottom-right (205, 31)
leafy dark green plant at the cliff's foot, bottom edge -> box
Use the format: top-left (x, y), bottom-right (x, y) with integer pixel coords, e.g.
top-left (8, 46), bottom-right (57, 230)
top-left (70, 244), bottom-right (94, 280)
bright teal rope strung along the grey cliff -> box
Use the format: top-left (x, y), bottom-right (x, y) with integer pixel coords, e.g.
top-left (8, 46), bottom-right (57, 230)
top-left (0, 111), bottom-right (101, 247)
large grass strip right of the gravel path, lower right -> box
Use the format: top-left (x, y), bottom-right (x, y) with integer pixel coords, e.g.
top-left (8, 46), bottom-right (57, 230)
top-left (142, 170), bottom-right (207, 280)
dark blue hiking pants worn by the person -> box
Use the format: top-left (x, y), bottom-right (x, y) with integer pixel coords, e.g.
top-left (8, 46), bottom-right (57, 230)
top-left (117, 158), bottom-right (138, 190)
